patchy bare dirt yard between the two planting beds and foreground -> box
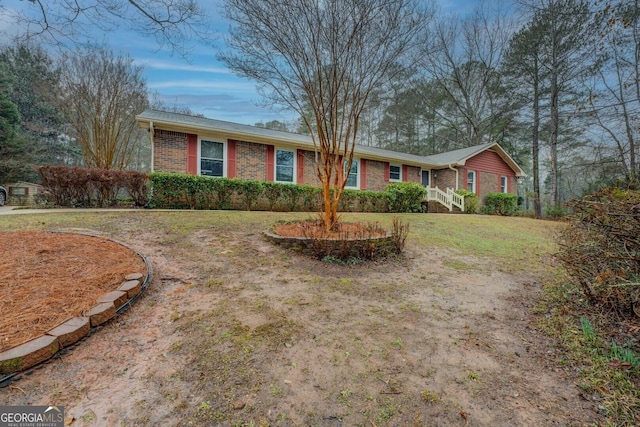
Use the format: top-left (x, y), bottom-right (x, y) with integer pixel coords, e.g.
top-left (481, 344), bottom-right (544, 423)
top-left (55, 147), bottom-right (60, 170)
top-left (0, 213), bottom-right (604, 426)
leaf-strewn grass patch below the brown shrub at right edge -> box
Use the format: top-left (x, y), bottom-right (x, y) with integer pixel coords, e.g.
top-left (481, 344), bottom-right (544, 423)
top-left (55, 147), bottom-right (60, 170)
top-left (536, 280), bottom-right (640, 427)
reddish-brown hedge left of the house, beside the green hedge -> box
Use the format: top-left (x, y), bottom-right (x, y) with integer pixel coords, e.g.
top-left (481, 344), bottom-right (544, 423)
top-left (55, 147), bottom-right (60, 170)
top-left (37, 165), bottom-right (149, 207)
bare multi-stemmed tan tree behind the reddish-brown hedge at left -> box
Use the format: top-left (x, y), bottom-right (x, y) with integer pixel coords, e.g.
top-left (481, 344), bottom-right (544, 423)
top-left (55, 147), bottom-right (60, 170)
top-left (57, 49), bottom-right (148, 169)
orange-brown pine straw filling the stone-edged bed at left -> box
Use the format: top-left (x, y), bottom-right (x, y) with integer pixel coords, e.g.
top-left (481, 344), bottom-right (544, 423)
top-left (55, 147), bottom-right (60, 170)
top-left (0, 231), bottom-right (146, 351)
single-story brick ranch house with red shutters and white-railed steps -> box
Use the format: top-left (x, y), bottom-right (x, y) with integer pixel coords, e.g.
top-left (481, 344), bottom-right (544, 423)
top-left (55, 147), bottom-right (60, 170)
top-left (136, 110), bottom-right (525, 211)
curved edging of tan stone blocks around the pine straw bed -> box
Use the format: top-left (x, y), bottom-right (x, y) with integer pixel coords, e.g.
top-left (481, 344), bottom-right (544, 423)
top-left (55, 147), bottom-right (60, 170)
top-left (0, 233), bottom-right (153, 388)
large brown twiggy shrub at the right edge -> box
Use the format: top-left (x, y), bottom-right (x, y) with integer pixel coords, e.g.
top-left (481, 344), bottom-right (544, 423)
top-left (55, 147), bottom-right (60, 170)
top-left (558, 188), bottom-right (640, 317)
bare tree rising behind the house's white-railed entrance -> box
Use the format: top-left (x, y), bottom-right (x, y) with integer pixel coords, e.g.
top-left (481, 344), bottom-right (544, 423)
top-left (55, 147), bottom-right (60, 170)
top-left (422, 2), bottom-right (511, 149)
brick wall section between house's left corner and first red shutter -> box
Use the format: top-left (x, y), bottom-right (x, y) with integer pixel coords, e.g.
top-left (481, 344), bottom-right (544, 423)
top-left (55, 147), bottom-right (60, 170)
top-left (153, 129), bottom-right (187, 173)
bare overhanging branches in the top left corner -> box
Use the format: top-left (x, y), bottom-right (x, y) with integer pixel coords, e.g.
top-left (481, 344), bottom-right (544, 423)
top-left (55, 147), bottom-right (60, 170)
top-left (0, 0), bottom-right (211, 53)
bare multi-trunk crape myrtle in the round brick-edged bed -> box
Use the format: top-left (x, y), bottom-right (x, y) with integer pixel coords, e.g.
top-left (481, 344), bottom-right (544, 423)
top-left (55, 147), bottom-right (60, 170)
top-left (220, 0), bottom-right (429, 230)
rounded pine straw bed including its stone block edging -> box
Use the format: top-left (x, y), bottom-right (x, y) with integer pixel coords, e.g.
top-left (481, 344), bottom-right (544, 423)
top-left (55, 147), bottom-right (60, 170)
top-left (0, 231), bottom-right (149, 374)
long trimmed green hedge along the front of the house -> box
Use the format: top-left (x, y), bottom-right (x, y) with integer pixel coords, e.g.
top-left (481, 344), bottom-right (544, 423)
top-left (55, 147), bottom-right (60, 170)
top-left (149, 172), bottom-right (425, 212)
